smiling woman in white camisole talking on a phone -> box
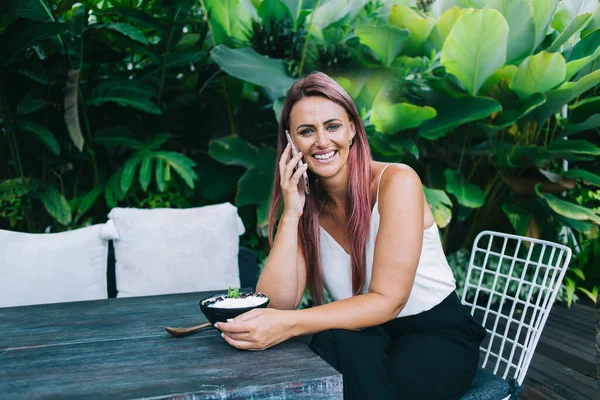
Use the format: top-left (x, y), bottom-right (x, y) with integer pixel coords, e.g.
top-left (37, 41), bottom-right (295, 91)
top-left (217, 73), bottom-right (485, 400)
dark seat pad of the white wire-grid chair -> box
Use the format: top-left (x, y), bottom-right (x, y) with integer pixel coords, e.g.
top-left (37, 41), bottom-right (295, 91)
top-left (461, 368), bottom-right (521, 400)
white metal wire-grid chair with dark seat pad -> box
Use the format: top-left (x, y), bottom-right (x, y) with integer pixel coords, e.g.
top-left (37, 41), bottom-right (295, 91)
top-left (461, 231), bottom-right (571, 400)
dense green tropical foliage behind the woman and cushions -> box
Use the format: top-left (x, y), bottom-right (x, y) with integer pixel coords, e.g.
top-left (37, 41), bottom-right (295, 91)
top-left (0, 0), bottom-right (600, 302)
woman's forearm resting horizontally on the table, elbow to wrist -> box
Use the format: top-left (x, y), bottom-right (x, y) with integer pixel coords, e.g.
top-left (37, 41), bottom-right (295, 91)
top-left (289, 293), bottom-right (406, 336)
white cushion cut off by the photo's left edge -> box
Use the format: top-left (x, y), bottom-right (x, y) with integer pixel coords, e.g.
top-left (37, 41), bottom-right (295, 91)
top-left (0, 225), bottom-right (108, 307)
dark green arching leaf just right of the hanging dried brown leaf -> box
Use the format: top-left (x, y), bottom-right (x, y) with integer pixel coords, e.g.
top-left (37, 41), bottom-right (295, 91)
top-left (87, 78), bottom-right (161, 115)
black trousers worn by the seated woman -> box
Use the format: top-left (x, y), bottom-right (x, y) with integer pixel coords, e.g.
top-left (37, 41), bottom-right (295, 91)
top-left (310, 292), bottom-right (486, 400)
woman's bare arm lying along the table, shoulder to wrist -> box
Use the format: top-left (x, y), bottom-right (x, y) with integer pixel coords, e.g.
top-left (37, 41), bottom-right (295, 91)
top-left (288, 165), bottom-right (424, 336)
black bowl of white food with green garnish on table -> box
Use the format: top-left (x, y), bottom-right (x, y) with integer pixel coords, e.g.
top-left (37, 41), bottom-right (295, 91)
top-left (199, 289), bottom-right (270, 324)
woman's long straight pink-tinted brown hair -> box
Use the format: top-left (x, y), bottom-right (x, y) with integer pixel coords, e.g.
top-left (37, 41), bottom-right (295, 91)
top-left (269, 72), bottom-right (371, 305)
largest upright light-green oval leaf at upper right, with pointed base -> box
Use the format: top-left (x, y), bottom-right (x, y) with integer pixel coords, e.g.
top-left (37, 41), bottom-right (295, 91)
top-left (440, 10), bottom-right (508, 96)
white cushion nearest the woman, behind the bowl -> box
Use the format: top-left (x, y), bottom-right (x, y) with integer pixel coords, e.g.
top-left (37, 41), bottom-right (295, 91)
top-left (104, 203), bottom-right (244, 297)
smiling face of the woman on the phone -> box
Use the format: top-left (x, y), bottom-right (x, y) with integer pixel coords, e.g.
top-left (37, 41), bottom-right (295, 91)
top-left (290, 96), bottom-right (356, 178)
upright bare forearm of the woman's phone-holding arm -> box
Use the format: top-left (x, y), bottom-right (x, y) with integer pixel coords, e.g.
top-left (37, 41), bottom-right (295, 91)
top-left (256, 216), bottom-right (304, 310)
